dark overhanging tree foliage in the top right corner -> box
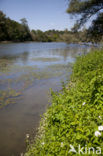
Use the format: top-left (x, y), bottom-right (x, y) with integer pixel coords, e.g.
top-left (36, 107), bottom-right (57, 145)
top-left (67, 0), bottom-right (103, 42)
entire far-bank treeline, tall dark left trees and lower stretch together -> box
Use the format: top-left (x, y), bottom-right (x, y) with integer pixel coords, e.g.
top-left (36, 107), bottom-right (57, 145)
top-left (0, 11), bottom-right (100, 43)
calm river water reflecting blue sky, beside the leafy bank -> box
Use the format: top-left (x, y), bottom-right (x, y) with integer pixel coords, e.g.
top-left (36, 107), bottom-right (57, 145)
top-left (0, 42), bottom-right (91, 156)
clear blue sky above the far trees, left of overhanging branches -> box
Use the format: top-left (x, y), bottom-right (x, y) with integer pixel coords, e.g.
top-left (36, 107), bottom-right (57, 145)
top-left (0, 0), bottom-right (75, 31)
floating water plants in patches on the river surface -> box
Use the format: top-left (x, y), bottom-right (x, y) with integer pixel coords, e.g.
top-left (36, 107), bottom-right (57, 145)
top-left (0, 57), bottom-right (71, 108)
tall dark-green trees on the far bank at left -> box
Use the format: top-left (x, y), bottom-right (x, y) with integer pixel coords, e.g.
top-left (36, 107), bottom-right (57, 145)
top-left (0, 11), bottom-right (32, 41)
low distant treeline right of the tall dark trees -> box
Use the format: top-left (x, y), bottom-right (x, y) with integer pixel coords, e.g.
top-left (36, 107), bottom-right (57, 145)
top-left (31, 29), bottom-right (88, 43)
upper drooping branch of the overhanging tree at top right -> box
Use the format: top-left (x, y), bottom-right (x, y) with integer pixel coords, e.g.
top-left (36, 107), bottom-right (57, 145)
top-left (67, 0), bottom-right (103, 29)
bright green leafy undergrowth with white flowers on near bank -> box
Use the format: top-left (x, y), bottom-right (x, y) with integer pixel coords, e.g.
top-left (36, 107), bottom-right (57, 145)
top-left (25, 50), bottom-right (103, 156)
